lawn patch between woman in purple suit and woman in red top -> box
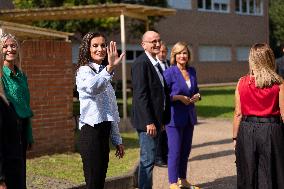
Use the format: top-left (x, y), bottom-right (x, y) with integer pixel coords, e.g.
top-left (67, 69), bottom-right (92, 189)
top-left (196, 86), bottom-right (235, 118)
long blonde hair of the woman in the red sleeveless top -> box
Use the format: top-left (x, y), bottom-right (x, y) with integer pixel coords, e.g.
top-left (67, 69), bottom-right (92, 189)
top-left (249, 43), bottom-right (283, 88)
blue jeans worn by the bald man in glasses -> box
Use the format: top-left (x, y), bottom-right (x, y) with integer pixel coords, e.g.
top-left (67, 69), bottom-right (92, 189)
top-left (138, 132), bottom-right (157, 189)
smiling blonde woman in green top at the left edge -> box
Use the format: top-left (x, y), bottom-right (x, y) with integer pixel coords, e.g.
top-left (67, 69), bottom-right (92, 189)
top-left (0, 34), bottom-right (33, 189)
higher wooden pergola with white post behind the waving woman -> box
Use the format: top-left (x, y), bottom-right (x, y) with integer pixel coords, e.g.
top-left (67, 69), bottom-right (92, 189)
top-left (0, 3), bottom-right (176, 120)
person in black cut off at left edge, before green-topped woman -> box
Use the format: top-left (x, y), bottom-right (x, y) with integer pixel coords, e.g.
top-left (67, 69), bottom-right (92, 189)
top-left (0, 92), bottom-right (26, 189)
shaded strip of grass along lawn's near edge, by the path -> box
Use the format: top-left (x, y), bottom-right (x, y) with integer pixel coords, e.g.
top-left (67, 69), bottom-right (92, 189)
top-left (196, 106), bottom-right (234, 118)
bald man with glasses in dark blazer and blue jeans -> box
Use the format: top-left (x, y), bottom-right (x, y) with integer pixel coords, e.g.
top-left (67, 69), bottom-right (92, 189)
top-left (131, 31), bottom-right (170, 189)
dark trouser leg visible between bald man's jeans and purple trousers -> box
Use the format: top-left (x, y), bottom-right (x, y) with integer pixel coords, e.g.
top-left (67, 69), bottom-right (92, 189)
top-left (156, 130), bottom-right (168, 163)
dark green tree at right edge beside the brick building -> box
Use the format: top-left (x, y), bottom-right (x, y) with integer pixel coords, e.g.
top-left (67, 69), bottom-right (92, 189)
top-left (269, 0), bottom-right (284, 57)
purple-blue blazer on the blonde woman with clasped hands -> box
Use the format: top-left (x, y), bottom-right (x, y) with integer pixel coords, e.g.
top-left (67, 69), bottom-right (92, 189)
top-left (164, 66), bottom-right (199, 127)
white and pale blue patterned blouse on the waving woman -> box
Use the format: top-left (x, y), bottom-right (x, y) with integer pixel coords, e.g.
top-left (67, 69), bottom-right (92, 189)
top-left (76, 63), bottom-right (122, 145)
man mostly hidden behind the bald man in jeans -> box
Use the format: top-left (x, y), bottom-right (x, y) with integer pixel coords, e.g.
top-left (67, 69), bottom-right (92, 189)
top-left (155, 41), bottom-right (170, 167)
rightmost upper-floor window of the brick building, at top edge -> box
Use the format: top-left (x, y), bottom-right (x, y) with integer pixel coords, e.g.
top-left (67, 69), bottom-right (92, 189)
top-left (235, 0), bottom-right (263, 15)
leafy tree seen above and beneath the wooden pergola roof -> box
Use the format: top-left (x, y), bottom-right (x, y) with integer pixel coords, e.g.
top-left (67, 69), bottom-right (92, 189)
top-left (13, 0), bottom-right (167, 36)
